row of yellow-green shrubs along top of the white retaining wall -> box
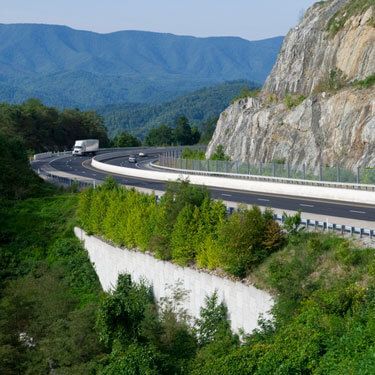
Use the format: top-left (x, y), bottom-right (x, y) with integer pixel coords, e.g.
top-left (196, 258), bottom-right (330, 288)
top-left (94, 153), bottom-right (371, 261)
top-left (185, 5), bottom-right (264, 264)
top-left (78, 180), bottom-right (285, 277)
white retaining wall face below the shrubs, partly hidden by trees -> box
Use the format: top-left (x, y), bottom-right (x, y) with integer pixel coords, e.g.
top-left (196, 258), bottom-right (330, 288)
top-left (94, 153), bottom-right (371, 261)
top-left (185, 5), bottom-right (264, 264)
top-left (74, 228), bottom-right (274, 333)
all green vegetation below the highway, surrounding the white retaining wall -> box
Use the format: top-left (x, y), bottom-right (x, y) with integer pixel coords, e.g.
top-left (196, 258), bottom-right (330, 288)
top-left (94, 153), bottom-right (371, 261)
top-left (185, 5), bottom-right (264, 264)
top-left (0, 101), bottom-right (375, 375)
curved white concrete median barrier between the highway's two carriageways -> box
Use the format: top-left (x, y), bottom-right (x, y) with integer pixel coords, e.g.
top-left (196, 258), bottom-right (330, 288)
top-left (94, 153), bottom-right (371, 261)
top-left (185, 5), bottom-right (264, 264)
top-left (91, 157), bottom-right (375, 204)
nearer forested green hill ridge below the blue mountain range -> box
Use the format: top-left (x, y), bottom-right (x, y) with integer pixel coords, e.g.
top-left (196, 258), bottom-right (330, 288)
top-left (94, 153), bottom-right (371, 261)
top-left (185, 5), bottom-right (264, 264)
top-left (96, 80), bottom-right (257, 137)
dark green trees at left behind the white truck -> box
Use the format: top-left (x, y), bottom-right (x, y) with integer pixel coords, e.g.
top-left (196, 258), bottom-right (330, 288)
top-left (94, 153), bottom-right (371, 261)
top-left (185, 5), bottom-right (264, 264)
top-left (0, 99), bottom-right (109, 153)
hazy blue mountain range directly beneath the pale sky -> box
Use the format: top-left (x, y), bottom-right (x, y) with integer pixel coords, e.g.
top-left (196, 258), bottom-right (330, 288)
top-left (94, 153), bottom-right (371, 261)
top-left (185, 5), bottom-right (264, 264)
top-left (0, 24), bottom-right (283, 108)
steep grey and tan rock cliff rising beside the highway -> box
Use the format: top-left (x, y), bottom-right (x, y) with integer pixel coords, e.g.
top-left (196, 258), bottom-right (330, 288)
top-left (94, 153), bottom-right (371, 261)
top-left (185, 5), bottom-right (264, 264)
top-left (207, 0), bottom-right (375, 168)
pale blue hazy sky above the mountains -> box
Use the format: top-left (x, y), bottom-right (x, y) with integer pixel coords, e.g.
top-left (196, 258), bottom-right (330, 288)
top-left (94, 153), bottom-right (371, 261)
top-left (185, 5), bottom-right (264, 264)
top-left (0, 0), bottom-right (315, 40)
